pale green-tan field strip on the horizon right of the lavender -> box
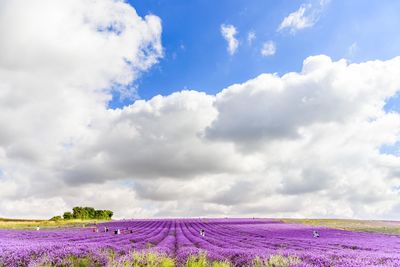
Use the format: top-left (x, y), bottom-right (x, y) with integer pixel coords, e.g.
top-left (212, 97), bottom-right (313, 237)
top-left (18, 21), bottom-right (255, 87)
top-left (281, 219), bottom-right (400, 234)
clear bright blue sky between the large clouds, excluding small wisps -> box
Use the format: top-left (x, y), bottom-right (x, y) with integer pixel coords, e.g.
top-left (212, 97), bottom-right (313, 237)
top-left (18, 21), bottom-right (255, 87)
top-left (110, 0), bottom-right (400, 107)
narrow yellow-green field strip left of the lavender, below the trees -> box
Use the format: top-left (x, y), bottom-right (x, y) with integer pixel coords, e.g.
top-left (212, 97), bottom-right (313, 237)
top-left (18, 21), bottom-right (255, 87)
top-left (0, 218), bottom-right (101, 230)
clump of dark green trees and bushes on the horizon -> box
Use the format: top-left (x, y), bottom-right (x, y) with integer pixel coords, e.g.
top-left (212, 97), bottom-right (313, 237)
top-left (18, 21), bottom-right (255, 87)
top-left (50, 207), bottom-right (113, 221)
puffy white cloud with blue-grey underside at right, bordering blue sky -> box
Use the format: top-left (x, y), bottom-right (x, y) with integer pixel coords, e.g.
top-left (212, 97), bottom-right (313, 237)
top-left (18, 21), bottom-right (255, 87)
top-left (207, 56), bottom-right (398, 145)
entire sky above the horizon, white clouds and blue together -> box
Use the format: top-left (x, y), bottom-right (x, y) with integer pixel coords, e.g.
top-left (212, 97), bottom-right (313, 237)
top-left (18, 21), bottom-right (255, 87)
top-left (0, 0), bottom-right (400, 219)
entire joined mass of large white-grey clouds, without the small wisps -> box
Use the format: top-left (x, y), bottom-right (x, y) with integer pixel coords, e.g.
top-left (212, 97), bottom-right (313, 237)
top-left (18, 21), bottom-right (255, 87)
top-left (0, 0), bottom-right (400, 222)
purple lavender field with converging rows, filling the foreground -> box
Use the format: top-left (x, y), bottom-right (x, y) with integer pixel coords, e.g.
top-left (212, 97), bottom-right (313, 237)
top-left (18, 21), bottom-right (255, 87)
top-left (0, 219), bottom-right (400, 266)
